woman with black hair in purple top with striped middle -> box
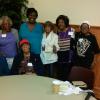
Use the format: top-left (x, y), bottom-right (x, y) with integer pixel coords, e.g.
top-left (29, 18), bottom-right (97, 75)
top-left (56, 15), bottom-right (74, 81)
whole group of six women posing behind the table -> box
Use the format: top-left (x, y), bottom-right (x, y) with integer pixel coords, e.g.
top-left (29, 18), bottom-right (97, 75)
top-left (0, 8), bottom-right (100, 80)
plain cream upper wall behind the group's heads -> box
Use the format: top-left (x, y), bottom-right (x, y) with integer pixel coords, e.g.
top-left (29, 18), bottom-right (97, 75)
top-left (28, 0), bottom-right (100, 26)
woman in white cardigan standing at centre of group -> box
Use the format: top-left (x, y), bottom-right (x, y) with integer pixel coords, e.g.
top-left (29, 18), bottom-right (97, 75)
top-left (40, 21), bottom-right (59, 77)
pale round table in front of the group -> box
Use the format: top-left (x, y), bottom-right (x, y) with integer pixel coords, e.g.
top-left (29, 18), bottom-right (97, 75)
top-left (0, 75), bottom-right (95, 100)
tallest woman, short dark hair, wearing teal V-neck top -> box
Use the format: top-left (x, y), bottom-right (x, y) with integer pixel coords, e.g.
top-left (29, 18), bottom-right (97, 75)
top-left (19, 8), bottom-right (43, 56)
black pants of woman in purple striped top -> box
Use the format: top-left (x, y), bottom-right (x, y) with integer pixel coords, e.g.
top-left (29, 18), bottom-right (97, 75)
top-left (57, 50), bottom-right (73, 81)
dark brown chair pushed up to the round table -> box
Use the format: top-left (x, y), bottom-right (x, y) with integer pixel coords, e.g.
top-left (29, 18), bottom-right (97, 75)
top-left (68, 66), bottom-right (94, 89)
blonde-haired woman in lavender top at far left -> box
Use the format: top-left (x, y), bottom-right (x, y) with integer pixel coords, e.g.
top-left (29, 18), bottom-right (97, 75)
top-left (0, 16), bottom-right (17, 69)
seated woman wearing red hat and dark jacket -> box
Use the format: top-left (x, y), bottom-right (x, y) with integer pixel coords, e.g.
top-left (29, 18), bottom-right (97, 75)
top-left (11, 39), bottom-right (43, 75)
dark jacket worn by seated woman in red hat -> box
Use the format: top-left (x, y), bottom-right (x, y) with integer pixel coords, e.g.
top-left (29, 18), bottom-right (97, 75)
top-left (11, 53), bottom-right (44, 75)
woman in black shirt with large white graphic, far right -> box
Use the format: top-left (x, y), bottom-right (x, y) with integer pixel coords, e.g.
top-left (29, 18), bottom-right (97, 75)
top-left (75, 22), bottom-right (100, 69)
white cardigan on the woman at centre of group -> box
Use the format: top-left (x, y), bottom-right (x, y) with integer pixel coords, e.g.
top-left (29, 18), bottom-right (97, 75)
top-left (40, 32), bottom-right (59, 64)
